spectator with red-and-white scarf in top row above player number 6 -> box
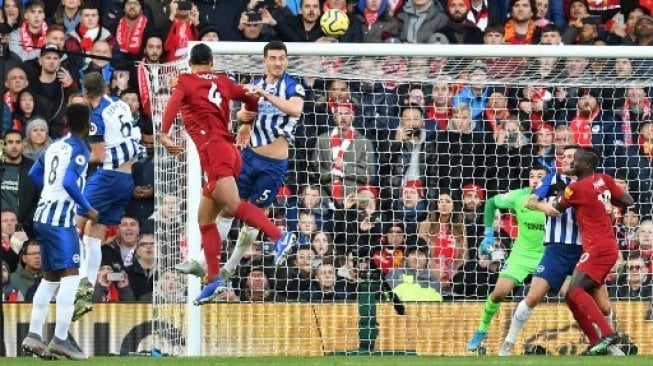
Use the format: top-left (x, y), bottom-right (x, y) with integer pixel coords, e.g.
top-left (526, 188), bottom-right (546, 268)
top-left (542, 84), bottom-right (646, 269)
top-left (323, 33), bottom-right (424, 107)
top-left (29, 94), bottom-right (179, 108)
top-left (113, 0), bottom-right (154, 61)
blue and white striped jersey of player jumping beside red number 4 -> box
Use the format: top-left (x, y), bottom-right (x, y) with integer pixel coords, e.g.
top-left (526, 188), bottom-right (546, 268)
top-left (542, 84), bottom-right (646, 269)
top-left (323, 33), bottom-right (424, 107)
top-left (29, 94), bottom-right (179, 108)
top-left (250, 73), bottom-right (305, 147)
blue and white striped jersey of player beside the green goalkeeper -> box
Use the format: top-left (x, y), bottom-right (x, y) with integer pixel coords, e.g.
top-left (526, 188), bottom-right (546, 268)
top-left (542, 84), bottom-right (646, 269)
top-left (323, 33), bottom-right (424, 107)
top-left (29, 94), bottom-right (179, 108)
top-left (533, 172), bottom-right (581, 245)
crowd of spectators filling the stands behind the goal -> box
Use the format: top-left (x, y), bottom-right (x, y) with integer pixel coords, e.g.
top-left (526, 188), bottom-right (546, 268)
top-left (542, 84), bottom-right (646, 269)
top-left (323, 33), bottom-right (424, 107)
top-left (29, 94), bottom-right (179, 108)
top-left (0, 0), bottom-right (653, 302)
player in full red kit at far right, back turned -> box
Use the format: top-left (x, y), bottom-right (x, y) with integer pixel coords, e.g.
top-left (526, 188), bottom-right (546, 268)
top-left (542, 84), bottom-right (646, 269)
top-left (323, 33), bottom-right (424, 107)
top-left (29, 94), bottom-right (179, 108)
top-left (551, 149), bottom-right (633, 355)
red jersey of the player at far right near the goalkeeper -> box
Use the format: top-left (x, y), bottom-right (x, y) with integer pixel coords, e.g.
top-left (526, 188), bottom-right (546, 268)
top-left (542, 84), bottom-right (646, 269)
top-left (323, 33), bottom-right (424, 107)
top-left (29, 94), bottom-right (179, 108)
top-left (560, 174), bottom-right (625, 251)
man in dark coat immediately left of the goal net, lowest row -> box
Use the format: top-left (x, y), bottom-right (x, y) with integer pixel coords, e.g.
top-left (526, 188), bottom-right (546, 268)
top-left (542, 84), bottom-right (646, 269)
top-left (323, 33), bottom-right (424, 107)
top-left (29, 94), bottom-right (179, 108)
top-left (125, 233), bottom-right (156, 302)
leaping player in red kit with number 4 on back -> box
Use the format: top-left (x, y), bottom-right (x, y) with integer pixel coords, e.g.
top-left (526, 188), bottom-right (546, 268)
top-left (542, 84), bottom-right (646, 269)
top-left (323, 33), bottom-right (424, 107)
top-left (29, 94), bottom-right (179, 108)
top-left (161, 44), bottom-right (294, 305)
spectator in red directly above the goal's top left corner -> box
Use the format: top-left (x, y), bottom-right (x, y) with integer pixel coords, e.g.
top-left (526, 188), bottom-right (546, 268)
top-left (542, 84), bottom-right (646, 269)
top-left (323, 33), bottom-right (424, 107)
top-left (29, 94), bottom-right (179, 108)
top-left (163, 0), bottom-right (199, 62)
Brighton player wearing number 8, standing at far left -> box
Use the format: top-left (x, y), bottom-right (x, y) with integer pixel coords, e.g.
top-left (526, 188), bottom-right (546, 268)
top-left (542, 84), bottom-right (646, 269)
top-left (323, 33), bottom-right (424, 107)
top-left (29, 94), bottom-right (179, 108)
top-left (22, 104), bottom-right (98, 360)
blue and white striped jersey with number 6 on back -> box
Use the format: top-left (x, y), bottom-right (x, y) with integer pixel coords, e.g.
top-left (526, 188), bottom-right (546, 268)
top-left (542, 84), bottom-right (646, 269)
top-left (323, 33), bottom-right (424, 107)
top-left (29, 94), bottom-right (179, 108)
top-left (89, 95), bottom-right (141, 170)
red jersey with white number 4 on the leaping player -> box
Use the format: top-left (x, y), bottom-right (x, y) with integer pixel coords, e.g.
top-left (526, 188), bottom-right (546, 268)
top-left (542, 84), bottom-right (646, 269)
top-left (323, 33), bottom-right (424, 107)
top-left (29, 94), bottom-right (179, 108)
top-left (161, 71), bottom-right (258, 149)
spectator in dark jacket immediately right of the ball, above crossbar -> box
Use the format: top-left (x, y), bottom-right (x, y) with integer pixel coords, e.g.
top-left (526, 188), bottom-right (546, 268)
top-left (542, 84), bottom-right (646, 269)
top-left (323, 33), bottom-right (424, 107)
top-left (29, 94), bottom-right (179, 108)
top-left (354, 0), bottom-right (399, 43)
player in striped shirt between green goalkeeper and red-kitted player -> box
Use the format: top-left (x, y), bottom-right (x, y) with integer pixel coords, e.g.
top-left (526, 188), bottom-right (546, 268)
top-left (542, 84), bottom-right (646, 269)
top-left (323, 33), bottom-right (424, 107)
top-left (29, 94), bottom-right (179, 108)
top-left (499, 145), bottom-right (624, 356)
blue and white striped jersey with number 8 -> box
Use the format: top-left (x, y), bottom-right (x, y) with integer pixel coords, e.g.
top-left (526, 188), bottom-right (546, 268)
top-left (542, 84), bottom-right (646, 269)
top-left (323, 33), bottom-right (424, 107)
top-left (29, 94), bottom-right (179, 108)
top-left (29, 135), bottom-right (90, 227)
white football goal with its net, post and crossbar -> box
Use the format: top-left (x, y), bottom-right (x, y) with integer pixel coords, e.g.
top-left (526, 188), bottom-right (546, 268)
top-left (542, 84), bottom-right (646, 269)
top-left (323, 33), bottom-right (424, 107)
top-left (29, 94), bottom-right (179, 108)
top-left (150, 42), bottom-right (653, 356)
